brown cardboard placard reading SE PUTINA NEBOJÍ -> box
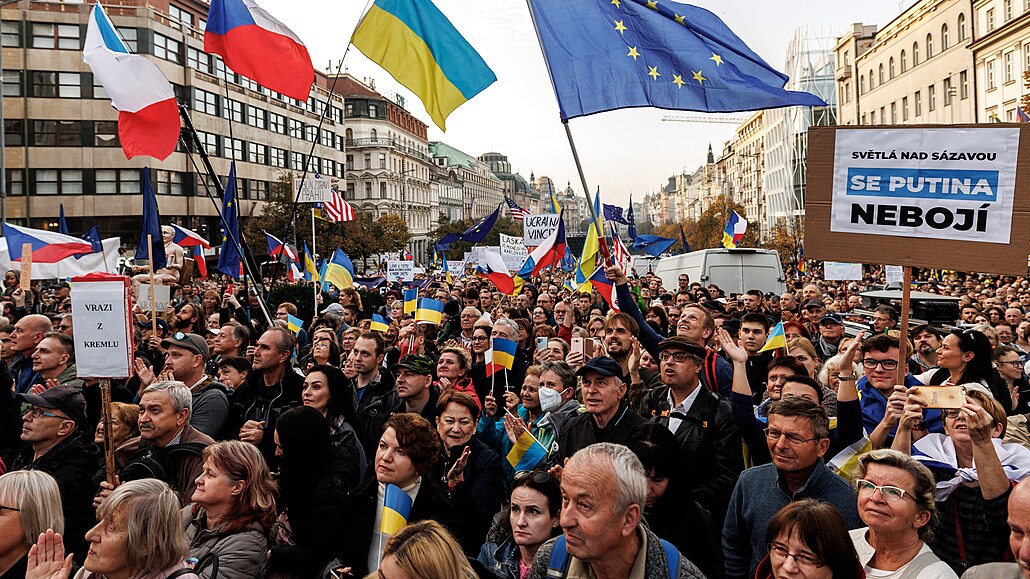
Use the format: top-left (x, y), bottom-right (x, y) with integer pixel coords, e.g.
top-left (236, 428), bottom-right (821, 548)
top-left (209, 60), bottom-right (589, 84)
top-left (804, 124), bottom-right (1030, 275)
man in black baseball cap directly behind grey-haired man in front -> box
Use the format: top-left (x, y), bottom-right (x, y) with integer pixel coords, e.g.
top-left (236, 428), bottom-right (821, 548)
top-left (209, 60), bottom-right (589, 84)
top-left (558, 355), bottom-right (647, 459)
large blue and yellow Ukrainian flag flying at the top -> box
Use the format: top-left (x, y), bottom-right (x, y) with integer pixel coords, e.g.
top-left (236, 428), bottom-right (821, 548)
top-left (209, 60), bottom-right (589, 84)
top-left (350, 0), bottom-right (497, 131)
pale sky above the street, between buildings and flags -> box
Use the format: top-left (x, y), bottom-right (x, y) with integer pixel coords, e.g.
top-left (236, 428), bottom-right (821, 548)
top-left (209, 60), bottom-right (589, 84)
top-left (261, 0), bottom-right (912, 205)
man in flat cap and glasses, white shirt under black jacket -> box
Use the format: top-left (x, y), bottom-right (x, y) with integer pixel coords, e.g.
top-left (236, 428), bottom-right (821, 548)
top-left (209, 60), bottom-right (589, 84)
top-left (642, 336), bottom-right (744, 522)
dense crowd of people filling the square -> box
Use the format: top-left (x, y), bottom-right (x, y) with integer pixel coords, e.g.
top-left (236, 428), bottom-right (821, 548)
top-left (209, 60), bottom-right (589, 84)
top-left (0, 265), bottom-right (1030, 579)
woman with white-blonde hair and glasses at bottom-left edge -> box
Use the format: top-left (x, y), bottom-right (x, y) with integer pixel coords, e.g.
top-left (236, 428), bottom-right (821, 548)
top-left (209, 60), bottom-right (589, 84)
top-left (0, 471), bottom-right (64, 579)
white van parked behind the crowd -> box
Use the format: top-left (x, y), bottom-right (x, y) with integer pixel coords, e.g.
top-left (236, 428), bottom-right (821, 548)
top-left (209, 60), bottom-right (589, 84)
top-left (655, 248), bottom-right (787, 296)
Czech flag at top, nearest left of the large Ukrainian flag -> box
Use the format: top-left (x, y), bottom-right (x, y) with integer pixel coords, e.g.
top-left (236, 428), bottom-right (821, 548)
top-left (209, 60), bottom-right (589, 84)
top-left (204, 0), bottom-right (315, 101)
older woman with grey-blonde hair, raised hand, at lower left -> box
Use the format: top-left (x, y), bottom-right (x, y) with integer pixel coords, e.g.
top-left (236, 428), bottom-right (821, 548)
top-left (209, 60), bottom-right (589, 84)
top-left (25, 478), bottom-right (199, 579)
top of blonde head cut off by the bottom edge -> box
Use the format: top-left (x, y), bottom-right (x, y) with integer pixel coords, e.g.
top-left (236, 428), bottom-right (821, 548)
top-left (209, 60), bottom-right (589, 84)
top-left (374, 520), bottom-right (476, 579)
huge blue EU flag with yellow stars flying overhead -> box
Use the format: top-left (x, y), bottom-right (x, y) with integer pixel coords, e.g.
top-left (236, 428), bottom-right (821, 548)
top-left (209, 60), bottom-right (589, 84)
top-left (529, 0), bottom-right (827, 121)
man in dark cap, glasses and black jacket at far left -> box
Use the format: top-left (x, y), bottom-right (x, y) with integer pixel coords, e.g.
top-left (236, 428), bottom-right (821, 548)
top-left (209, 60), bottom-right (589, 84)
top-left (10, 386), bottom-right (101, 560)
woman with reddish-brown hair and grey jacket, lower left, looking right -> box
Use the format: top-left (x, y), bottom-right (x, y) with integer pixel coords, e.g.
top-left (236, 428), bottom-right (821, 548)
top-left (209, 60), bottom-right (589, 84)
top-left (182, 440), bottom-right (276, 579)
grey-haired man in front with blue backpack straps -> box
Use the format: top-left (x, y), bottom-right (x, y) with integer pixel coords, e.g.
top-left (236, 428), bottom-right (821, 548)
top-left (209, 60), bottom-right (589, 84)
top-left (529, 443), bottom-right (703, 579)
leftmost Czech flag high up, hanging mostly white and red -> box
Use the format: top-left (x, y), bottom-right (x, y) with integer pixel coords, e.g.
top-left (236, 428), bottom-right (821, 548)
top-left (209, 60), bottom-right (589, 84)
top-left (82, 2), bottom-right (179, 160)
